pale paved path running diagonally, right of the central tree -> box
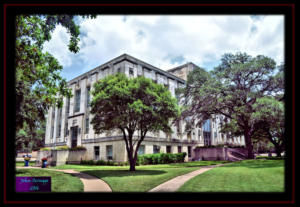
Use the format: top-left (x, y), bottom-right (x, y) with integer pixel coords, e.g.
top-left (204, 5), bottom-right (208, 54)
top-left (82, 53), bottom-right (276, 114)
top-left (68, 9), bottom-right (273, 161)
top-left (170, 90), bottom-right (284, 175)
top-left (149, 164), bottom-right (224, 192)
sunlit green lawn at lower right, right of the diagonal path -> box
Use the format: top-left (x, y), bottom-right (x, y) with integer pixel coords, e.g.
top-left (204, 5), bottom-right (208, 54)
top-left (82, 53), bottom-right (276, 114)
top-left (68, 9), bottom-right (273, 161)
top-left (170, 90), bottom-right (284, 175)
top-left (178, 160), bottom-right (284, 192)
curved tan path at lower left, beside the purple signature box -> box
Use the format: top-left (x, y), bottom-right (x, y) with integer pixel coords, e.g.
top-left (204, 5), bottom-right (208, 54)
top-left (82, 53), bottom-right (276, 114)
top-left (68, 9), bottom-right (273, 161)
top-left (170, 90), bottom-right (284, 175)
top-left (17, 166), bottom-right (112, 192)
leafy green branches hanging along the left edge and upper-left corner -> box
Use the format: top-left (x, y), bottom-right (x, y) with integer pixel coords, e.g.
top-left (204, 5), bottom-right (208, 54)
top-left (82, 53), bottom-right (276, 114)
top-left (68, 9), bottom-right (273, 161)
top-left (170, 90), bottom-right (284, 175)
top-left (15, 15), bottom-right (94, 152)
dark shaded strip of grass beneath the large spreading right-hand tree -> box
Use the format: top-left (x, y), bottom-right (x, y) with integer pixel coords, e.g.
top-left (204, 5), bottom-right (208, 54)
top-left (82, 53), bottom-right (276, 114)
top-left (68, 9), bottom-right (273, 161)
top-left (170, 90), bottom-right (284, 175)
top-left (222, 160), bottom-right (284, 168)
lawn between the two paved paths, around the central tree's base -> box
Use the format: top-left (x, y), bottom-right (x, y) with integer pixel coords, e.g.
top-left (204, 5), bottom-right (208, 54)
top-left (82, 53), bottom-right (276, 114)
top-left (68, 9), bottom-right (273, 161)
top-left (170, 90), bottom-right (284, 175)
top-left (51, 161), bottom-right (224, 192)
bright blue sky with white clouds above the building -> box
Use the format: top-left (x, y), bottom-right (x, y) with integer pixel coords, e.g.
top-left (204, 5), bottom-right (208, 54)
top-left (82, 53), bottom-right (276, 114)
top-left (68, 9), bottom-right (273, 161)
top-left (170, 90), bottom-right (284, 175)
top-left (44, 15), bottom-right (284, 81)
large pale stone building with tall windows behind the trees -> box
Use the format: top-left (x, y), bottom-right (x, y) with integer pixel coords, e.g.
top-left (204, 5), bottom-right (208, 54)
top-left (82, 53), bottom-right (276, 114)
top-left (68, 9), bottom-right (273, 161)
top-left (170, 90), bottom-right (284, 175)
top-left (45, 54), bottom-right (245, 162)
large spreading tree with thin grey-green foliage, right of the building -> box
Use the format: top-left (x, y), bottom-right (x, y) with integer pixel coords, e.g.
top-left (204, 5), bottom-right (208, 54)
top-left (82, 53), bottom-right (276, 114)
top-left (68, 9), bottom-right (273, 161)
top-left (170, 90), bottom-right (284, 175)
top-left (178, 53), bottom-right (284, 159)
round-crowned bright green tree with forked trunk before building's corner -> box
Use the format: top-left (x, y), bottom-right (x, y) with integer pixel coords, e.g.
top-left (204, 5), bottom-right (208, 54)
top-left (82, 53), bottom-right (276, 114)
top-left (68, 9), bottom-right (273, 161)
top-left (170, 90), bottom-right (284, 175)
top-left (91, 73), bottom-right (179, 171)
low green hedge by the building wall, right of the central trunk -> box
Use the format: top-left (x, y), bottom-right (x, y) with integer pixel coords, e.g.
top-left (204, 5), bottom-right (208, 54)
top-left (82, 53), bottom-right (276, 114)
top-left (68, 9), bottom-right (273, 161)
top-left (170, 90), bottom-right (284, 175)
top-left (137, 152), bottom-right (186, 165)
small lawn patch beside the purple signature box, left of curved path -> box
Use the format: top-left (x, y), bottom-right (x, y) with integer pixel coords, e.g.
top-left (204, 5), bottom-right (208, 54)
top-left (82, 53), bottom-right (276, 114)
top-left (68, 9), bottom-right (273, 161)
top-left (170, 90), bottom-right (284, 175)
top-left (16, 169), bottom-right (83, 192)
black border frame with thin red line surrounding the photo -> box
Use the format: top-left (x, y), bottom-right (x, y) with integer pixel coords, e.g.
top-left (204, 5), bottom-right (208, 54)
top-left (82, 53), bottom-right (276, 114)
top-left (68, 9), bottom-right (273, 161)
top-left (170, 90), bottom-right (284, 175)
top-left (3, 3), bottom-right (296, 204)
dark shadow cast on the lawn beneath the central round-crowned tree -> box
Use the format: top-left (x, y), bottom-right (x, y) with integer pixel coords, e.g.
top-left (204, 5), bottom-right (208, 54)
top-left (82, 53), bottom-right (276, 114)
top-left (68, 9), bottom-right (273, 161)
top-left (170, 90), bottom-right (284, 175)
top-left (81, 170), bottom-right (167, 178)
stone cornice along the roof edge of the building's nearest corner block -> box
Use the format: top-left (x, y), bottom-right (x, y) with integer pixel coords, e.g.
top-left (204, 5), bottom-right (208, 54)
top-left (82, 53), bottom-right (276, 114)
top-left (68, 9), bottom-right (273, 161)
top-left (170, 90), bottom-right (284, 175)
top-left (68, 53), bottom-right (186, 85)
